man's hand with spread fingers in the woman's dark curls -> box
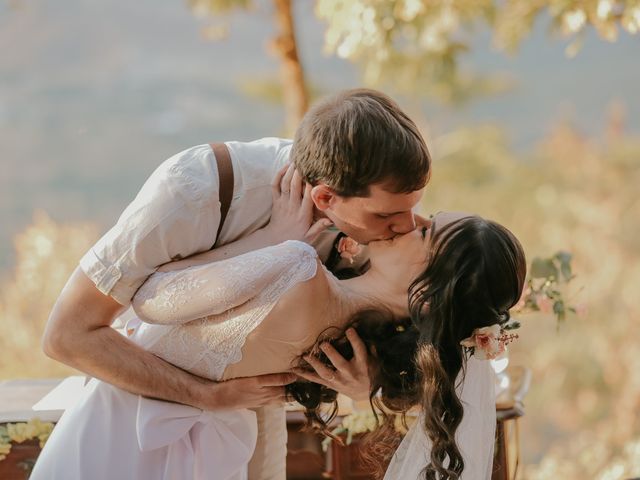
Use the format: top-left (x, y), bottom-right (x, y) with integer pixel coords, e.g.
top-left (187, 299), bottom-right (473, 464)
top-left (295, 328), bottom-right (371, 401)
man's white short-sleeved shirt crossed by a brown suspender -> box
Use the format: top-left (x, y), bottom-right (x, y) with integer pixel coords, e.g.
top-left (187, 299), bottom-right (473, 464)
top-left (80, 137), bottom-right (292, 306)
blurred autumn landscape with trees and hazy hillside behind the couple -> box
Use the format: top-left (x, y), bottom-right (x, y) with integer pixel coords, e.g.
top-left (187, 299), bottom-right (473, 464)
top-left (0, 0), bottom-right (640, 479)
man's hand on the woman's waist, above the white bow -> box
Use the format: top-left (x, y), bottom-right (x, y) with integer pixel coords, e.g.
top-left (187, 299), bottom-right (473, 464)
top-left (196, 373), bottom-right (296, 410)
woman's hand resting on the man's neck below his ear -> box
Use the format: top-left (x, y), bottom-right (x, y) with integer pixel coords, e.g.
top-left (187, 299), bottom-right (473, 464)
top-left (263, 164), bottom-right (332, 243)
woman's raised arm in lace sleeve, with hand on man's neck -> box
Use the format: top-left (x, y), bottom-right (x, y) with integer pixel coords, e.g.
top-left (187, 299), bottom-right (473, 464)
top-left (132, 166), bottom-right (330, 324)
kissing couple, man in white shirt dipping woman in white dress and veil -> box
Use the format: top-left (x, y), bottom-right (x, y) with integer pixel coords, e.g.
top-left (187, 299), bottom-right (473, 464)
top-left (31, 89), bottom-right (526, 480)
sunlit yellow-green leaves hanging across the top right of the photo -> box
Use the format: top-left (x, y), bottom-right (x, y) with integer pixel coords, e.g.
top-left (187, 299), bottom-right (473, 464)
top-left (316, 0), bottom-right (640, 96)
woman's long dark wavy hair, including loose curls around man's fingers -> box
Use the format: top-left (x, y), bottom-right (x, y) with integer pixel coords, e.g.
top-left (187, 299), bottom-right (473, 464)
top-left (287, 216), bottom-right (526, 480)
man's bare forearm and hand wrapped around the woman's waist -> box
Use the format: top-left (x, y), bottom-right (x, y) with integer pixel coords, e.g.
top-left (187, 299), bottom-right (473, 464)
top-left (43, 268), bottom-right (295, 410)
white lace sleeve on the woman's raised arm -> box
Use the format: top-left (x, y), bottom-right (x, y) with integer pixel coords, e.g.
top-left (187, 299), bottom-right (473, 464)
top-left (133, 240), bottom-right (317, 324)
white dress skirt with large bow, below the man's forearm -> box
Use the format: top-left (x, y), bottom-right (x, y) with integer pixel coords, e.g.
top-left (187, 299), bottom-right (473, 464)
top-left (30, 379), bottom-right (257, 480)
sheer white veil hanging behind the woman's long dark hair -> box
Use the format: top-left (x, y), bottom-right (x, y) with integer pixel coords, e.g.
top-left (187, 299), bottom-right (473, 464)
top-left (384, 356), bottom-right (496, 480)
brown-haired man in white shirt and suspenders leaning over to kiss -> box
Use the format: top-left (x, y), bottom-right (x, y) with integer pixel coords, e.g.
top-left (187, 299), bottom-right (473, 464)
top-left (43, 89), bottom-right (430, 480)
